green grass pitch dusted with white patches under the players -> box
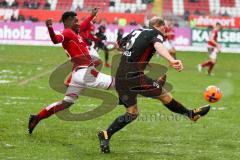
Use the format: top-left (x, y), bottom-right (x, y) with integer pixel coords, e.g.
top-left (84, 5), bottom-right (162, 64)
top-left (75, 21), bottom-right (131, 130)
top-left (0, 45), bottom-right (240, 160)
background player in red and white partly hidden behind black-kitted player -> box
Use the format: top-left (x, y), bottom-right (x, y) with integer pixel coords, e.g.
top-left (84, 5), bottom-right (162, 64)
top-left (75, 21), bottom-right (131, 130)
top-left (163, 22), bottom-right (176, 59)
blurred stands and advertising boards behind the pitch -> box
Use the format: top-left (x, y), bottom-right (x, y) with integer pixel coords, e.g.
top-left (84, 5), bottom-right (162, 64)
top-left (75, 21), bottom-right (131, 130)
top-left (0, 0), bottom-right (240, 52)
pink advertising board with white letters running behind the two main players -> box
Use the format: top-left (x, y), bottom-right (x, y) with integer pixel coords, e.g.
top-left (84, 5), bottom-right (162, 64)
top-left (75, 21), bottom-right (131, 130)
top-left (0, 22), bottom-right (191, 46)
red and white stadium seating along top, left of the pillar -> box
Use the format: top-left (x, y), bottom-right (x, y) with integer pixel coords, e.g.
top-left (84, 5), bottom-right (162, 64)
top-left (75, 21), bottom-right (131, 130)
top-left (0, 0), bottom-right (151, 13)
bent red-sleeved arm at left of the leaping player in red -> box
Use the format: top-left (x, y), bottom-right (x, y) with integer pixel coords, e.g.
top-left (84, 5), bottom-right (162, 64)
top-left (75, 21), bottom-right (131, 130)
top-left (45, 19), bottom-right (64, 44)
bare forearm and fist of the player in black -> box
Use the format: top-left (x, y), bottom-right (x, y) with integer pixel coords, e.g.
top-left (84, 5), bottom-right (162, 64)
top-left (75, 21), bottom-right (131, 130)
top-left (154, 42), bottom-right (183, 72)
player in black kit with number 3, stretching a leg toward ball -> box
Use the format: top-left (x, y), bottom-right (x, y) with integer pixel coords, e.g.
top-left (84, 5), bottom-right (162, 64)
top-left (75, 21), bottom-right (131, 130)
top-left (98, 17), bottom-right (210, 153)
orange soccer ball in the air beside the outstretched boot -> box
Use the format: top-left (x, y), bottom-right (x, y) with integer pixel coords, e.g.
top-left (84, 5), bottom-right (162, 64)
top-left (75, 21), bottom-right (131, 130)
top-left (204, 86), bottom-right (222, 103)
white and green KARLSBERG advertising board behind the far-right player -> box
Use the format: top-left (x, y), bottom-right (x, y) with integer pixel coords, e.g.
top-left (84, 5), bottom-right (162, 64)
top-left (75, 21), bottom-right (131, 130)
top-left (192, 28), bottom-right (240, 49)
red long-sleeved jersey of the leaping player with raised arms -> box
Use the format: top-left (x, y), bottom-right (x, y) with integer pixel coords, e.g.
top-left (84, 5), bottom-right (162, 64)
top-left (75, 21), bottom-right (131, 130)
top-left (48, 16), bottom-right (93, 68)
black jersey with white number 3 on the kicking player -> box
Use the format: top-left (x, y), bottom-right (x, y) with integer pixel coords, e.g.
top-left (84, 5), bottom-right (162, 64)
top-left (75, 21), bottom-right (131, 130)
top-left (116, 29), bottom-right (164, 76)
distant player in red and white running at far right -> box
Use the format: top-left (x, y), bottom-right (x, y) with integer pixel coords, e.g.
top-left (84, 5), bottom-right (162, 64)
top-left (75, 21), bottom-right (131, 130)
top-left (198, 23), bottom-right (222, 76)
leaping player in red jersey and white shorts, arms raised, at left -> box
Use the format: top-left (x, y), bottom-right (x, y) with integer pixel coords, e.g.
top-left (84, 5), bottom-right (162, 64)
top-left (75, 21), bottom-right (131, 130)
top-left (28, 8), bottom-right (115, 134)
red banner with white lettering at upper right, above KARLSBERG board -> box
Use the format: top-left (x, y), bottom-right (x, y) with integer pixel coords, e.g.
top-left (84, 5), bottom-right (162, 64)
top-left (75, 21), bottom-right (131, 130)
top-left (189, 16), bottom-right (240, 28)
